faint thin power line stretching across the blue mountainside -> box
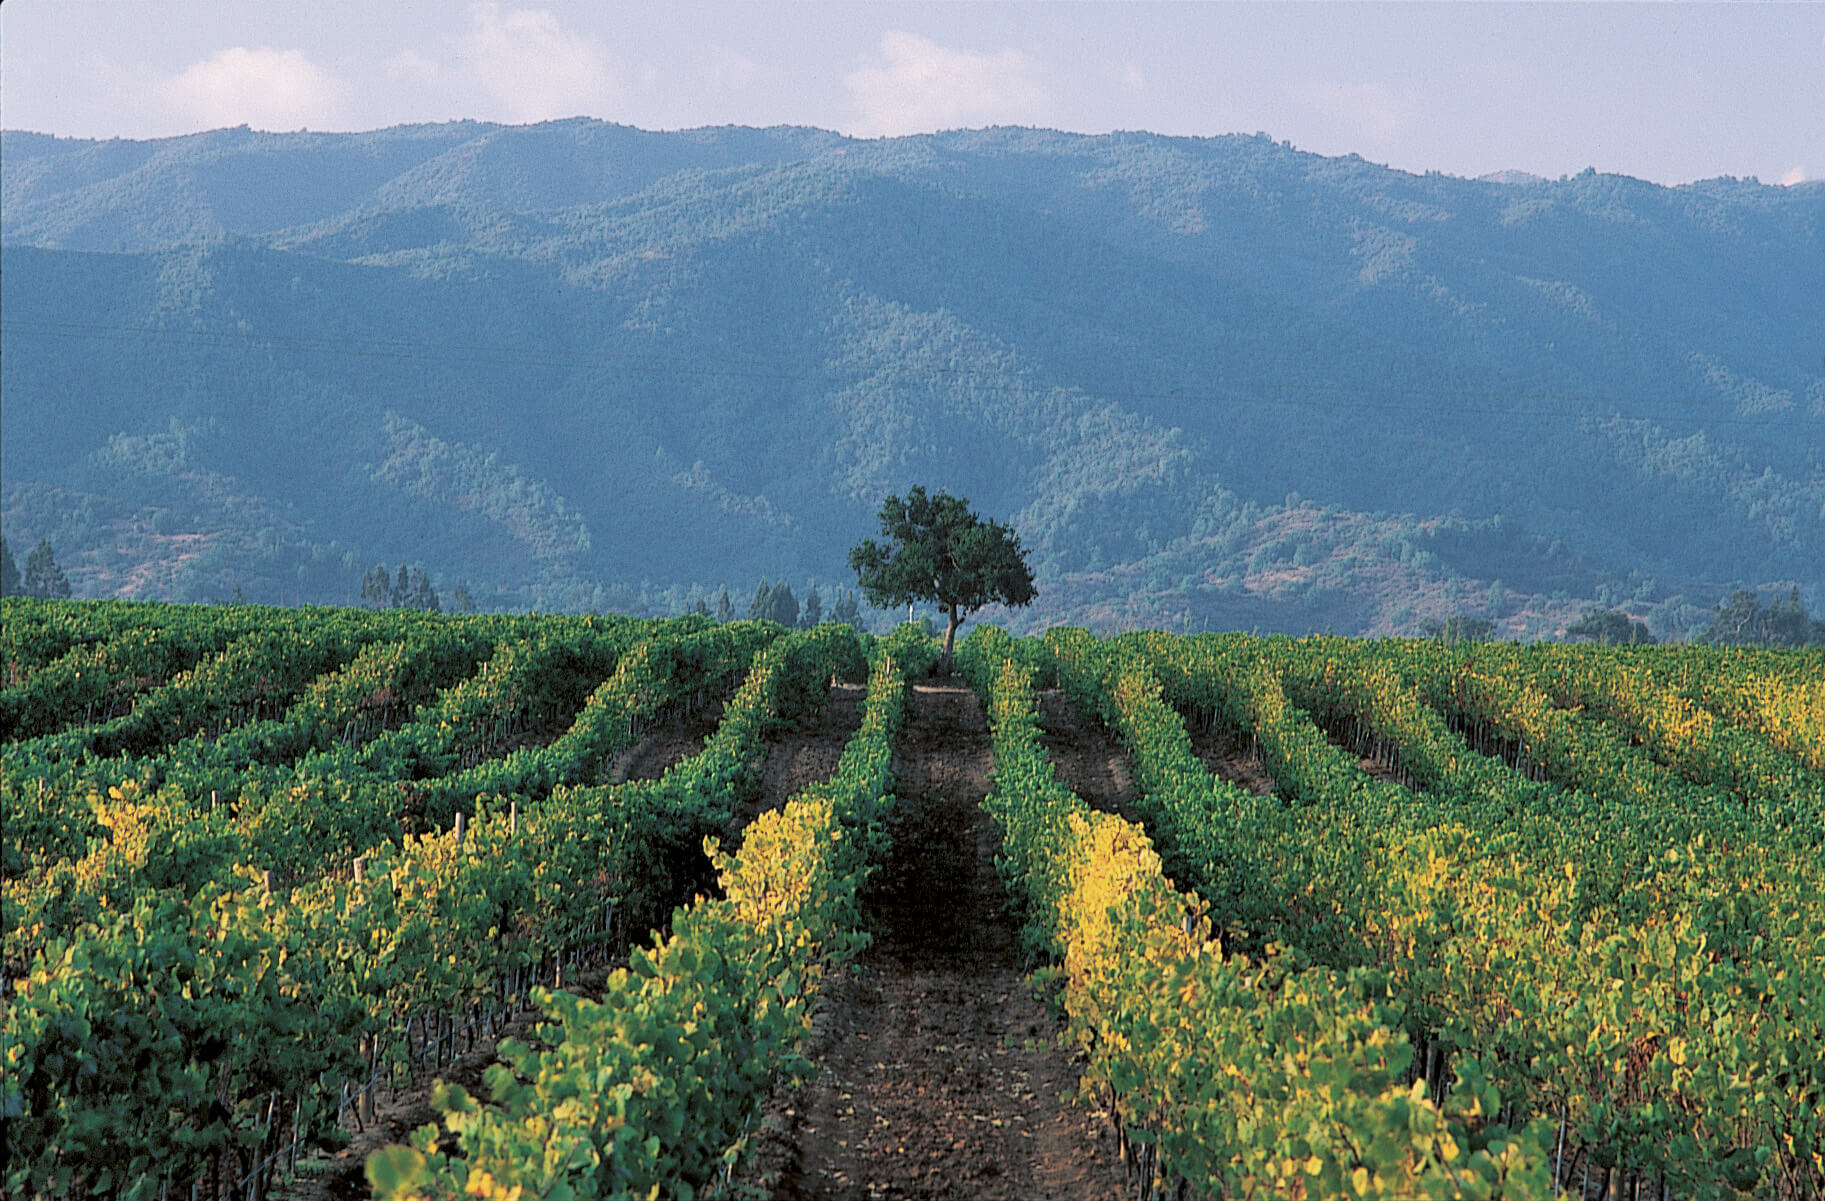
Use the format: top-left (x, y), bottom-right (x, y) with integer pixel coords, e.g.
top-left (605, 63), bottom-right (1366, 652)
top-left (0, 321), bottom-right (1816, 429)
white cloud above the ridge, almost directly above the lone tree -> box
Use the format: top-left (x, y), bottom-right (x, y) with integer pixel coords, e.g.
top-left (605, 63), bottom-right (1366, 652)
top-left (843, 29), bottom-right (1051, 137)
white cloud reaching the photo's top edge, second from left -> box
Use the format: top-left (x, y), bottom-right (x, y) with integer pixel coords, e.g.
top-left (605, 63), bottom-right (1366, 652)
top-left (458, 4), bottom-right (619, 120)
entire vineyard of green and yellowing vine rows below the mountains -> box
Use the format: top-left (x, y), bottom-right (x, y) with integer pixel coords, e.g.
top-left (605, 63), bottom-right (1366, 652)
top-left (0, 599), bottom-right (1825, 1201)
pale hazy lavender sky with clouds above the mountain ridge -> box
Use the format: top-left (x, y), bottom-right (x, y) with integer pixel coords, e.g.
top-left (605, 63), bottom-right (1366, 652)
top-left (0, 0), bottom-right (1825, 183)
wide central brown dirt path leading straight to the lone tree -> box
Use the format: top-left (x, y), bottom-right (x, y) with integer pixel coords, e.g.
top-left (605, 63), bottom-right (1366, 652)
top-left (735, 683), bottom-right (1124, 1201)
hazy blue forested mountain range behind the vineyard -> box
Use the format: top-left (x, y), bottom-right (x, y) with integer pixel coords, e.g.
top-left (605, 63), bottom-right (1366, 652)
top-left (0, 120), bottom-right (1825, 635)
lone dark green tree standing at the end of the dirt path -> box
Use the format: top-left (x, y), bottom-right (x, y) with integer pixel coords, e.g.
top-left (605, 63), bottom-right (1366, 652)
top-left (849, 487), bottom-right (1033, 672)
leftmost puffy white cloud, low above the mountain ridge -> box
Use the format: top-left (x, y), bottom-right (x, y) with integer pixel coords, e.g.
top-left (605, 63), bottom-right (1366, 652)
top-left (162, 46), bottom-right (343, 130)
